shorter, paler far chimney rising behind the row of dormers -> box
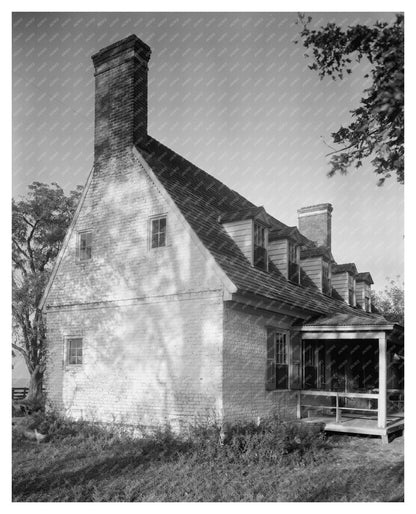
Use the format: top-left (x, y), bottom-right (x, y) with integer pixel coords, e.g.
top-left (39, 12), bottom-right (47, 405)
top-left (298, 203), bottom-right (332, 251)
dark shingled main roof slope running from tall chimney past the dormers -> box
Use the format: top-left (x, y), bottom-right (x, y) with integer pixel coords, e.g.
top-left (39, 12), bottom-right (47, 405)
top-left (137, 136), bottom-right (387, 323)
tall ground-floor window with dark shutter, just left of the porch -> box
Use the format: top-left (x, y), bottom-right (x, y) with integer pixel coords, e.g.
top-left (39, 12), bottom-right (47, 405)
top-left (266, 329), bottom-right (289, 391)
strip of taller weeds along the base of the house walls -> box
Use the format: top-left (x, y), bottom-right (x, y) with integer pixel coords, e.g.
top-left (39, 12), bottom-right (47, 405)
top-left (13, 412), bottom-right (325, 465)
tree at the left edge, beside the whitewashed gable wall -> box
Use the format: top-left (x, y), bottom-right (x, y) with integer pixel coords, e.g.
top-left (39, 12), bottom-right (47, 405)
top-left (12, 182), bottom-right (82, 401)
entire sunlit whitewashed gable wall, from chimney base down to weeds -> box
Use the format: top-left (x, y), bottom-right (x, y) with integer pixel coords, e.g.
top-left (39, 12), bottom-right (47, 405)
top-left (47, 150), bottom-right (222, 425)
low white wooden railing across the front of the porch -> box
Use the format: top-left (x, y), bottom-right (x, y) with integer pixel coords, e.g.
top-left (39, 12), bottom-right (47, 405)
top-left (297, 390), bottom-right (379, 423)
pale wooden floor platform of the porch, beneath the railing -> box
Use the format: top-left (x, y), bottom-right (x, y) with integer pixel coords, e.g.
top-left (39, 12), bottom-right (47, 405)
top-left (301, 413), bottom-right (404, 442)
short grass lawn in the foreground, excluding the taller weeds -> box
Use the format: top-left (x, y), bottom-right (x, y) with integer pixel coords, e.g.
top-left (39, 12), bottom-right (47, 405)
top-left (13, 416), bottom-right (404, 502)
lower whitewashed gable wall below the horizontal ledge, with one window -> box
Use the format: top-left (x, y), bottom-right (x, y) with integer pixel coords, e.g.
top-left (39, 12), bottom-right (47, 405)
top-left (47, 293), bottom-right (222, 426)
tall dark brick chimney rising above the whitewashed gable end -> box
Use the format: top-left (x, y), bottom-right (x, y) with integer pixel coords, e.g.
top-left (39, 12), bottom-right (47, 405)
top-left (92, 35), bottom-right (151, 163)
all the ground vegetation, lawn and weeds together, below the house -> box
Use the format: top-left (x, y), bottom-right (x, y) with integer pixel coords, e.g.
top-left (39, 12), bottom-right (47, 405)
top-left (13, 415), bottom-right (403, 502)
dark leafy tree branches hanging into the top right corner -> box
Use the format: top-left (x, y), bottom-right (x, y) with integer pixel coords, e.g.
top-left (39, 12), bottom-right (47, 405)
top-left (296, 14), bottom-right (404, 185)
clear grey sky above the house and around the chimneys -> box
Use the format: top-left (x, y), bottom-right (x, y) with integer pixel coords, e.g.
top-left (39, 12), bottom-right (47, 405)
top-left (12, 12), bottom-right (404, 289)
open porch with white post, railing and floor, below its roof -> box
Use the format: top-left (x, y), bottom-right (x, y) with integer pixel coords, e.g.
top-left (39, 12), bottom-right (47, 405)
top-left (297, 325), bottom-right (404, 442)
